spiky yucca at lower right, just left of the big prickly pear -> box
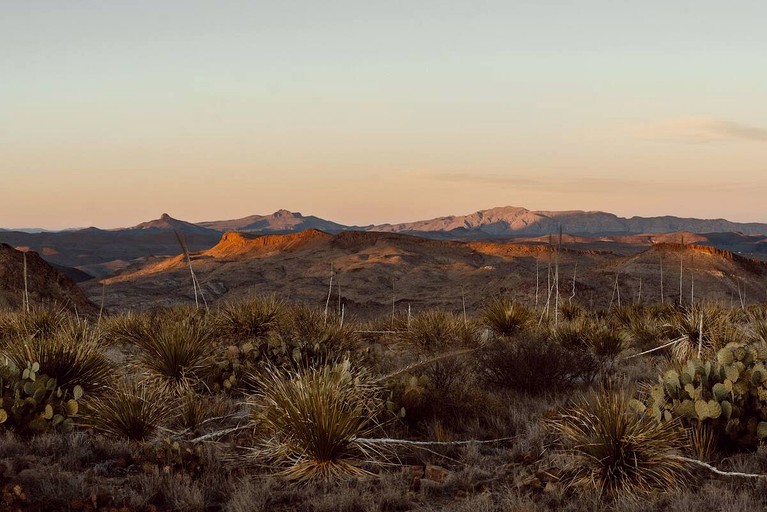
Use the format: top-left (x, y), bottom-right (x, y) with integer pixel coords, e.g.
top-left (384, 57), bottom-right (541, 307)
top-left (548, 385), bottom-right (690, 497)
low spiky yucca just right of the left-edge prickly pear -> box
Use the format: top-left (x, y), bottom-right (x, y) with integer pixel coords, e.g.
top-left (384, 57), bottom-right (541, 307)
top-left (83, 380), bottom-right (174, 441)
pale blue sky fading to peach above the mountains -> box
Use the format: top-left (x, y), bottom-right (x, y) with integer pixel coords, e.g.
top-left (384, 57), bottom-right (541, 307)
top-left (0, 0), bottom-right (767, 229)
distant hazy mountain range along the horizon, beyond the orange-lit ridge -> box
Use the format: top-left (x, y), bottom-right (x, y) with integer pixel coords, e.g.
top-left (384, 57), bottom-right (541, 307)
top-left (0, 206), bottom-right (767, 281)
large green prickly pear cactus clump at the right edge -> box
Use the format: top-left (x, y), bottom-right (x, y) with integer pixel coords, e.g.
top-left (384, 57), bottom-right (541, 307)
top-left (633, 343), bottom-right (767, 447)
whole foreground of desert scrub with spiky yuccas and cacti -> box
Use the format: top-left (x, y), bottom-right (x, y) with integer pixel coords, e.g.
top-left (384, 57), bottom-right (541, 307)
top-left (0, 297), bottom-right (767, 511)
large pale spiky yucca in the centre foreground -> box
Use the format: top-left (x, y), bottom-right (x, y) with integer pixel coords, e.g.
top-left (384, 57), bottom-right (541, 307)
top-left (252, 360), bottom-right (385, 482)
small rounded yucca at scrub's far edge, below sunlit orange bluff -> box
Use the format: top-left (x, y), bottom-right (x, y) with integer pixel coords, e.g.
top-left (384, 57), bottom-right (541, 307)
top-left (215, 295), bottom-right (287, 339)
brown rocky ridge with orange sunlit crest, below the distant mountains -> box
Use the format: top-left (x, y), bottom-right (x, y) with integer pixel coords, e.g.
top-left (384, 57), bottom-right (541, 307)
top-left (83, 231), bottom-right (767, 315)
